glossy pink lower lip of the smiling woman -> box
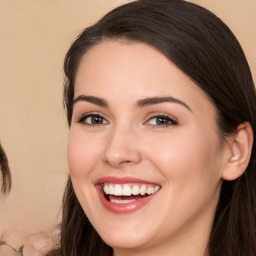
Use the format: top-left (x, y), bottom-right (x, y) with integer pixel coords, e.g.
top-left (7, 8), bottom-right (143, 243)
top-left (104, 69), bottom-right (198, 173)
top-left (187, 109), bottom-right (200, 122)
top-left (96, 185), bottom-right (158, 214)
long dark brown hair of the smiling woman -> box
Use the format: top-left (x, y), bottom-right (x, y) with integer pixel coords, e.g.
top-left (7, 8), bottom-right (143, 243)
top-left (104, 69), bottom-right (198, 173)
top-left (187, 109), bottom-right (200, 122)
top-left (49, 0), bottom-right (256, 256)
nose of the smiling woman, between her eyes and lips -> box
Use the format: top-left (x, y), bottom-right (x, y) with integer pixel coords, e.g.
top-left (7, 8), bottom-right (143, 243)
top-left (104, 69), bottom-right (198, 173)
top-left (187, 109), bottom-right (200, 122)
top-left (103, 124), bottom-right (141, 168)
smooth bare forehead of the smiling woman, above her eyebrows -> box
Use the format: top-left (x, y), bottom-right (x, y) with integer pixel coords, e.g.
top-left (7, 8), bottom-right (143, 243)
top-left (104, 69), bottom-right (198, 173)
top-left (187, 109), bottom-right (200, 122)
top-left (75, 41), bottom-right (214, 115)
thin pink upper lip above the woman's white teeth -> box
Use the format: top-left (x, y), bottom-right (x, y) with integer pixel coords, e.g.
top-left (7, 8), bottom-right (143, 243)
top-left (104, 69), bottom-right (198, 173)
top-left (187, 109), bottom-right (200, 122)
top-left (95, 176), bottom-right (159, 185)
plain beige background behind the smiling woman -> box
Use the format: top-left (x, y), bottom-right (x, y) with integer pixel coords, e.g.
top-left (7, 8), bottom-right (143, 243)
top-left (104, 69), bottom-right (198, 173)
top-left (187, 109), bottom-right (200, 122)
top-left (0, 0), bottom-right (256, 242)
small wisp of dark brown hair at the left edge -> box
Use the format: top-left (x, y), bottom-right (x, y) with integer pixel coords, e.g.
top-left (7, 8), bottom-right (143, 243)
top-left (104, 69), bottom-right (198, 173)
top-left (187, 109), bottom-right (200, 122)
top-left (0, 144), bottom-right (12, 194)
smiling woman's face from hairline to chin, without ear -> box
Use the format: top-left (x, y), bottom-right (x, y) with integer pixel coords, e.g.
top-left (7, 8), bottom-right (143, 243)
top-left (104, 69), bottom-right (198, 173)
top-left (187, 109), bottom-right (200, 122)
top-left (68, 41), bottom-right (228, 255)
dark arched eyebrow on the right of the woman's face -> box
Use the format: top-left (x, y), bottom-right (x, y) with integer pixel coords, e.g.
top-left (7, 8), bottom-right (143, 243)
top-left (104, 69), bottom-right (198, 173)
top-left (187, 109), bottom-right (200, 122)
top-left (137, 96), bottom-right (192, 112)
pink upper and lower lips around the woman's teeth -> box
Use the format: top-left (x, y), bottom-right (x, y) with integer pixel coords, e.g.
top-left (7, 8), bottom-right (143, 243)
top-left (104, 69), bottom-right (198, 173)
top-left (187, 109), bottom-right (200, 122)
top-left (95, 177), bottom-right (159, 214)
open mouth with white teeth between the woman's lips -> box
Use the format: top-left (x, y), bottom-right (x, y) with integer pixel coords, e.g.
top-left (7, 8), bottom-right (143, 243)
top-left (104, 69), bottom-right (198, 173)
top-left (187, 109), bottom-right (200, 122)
top-left (102, 183), bottom-right (160, 204)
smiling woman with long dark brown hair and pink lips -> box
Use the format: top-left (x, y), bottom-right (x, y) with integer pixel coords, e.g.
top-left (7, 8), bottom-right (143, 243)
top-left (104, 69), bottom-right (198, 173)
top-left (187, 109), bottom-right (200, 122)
top-left (49, 0), bottom-right (256, 256)
